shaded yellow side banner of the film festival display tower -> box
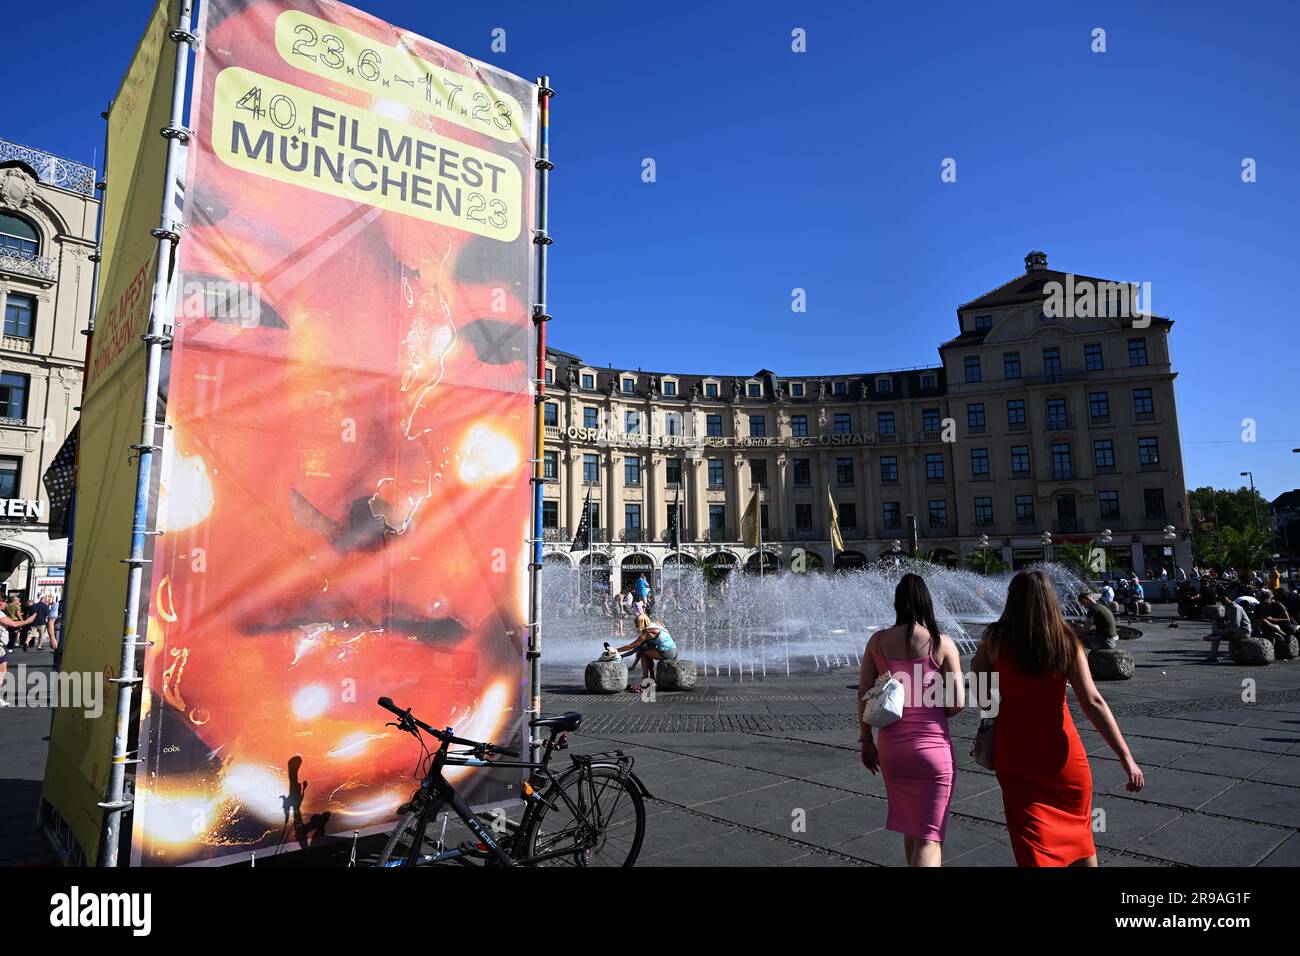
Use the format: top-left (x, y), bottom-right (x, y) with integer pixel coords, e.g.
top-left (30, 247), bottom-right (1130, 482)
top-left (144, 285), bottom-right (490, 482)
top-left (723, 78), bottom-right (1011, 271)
top-left (43, 0), bottom-right (179, 862)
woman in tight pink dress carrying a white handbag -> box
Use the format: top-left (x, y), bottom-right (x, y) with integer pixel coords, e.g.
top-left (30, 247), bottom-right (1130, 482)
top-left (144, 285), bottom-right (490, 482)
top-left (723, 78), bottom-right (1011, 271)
top-left (858, 574), bottom-right (966, 866)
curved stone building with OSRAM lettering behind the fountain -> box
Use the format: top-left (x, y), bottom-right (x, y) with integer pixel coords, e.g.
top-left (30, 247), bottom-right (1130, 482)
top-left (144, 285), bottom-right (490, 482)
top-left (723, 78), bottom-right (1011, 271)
top-left (543, 252), bottom-right (1191, 587)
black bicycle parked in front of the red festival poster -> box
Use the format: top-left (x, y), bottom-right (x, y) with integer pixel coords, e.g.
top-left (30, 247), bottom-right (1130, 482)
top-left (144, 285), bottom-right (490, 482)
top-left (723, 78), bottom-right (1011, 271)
top-left (378, 697), bottom-right (650, 866)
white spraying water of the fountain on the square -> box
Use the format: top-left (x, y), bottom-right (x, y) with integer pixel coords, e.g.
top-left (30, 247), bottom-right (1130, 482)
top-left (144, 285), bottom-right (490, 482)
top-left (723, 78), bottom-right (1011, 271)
top-left (541, 561), bottom-right (1084, 679)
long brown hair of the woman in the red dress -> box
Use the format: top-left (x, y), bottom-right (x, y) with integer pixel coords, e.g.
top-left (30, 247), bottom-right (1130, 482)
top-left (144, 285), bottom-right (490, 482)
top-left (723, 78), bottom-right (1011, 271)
top-left (984, 571), bottom-right (1080, 676)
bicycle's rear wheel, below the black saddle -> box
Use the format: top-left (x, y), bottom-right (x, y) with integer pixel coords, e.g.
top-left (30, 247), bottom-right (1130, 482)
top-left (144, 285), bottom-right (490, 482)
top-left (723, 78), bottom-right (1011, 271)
top-left (520, 766), bottom-right (646, 866)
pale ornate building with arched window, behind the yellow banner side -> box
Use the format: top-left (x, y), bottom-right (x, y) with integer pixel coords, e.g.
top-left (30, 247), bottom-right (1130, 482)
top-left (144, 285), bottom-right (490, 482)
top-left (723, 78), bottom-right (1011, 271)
top-left (0, 139), bottom-right (99, 593)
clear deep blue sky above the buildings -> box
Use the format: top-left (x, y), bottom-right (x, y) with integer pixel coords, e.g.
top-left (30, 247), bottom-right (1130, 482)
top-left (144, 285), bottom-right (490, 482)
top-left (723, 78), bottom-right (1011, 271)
top-left (10, 0), bottom-right (1300, 498)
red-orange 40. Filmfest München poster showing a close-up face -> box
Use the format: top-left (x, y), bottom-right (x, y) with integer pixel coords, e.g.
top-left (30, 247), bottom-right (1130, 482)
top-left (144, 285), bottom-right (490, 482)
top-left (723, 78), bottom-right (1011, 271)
top-left (131, 0), bottom-right (536, 864)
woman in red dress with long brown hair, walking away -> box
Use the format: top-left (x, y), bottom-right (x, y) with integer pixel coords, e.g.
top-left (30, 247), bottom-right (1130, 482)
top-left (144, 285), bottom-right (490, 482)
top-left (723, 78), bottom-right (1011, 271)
top-left (971, 571), bottom-right (1143, 866)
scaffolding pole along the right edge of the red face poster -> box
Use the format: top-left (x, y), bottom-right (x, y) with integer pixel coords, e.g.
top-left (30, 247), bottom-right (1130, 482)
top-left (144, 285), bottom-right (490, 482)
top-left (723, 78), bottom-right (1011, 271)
top-left (527, 77), bottom-right (551, 760)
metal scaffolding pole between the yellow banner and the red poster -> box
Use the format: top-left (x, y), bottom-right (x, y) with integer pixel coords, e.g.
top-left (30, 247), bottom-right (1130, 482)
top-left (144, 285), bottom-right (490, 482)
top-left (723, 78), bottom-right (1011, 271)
top-left (98, 0), bottom-right (195, 866)
